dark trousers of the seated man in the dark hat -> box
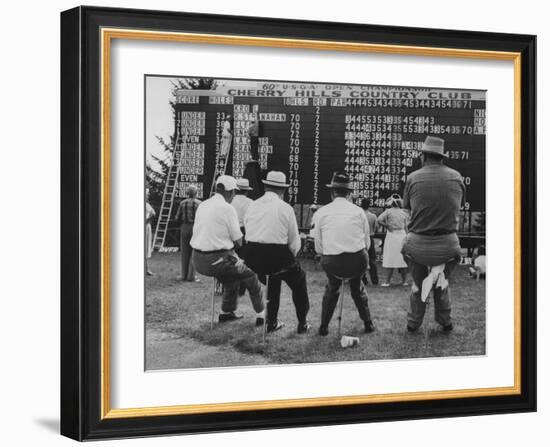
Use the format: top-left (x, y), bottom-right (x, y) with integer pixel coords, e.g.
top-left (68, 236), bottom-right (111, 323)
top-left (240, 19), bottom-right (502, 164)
top-left (321, 250), bottom-right (371, 328)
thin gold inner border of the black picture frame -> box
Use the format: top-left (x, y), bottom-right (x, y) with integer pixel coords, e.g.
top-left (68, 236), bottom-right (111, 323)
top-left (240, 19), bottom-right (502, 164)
top-left (100, 28), bottom-right (521, 419)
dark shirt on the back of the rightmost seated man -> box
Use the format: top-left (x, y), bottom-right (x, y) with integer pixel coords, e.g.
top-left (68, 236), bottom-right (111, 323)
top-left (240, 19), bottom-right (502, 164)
top-left (403, 164), bottom-right (465, 234)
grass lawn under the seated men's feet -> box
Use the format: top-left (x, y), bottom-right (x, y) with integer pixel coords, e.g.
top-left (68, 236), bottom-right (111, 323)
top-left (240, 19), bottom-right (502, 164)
top-left (145, 253), bottom-right (485, 369)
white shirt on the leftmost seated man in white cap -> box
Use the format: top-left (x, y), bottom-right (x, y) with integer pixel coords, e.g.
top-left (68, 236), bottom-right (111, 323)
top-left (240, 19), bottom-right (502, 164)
top-left (191, 193), bottom-right (243, 251)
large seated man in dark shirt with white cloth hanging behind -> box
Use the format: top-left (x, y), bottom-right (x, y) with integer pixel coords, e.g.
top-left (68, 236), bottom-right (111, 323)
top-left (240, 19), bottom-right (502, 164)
top-left (403, 136), bottom-right (465, 332)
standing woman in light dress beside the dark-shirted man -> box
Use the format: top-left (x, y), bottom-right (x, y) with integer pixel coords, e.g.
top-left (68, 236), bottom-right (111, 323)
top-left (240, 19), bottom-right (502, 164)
top-left (376, 194), bottom-right (408, 287)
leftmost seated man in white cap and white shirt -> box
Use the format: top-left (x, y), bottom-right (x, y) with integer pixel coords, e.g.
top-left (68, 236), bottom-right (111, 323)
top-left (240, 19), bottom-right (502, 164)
top-left (191, 175), bottom-right (264, 326)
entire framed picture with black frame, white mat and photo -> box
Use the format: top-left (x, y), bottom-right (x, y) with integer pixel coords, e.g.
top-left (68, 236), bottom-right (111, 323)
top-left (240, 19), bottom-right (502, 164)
top-left (61, 7), bottom-right (536, 440)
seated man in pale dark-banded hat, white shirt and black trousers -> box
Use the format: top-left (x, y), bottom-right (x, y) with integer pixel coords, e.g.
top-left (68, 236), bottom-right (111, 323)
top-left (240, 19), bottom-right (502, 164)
top-left (244, 171), bottom-right (310, 334)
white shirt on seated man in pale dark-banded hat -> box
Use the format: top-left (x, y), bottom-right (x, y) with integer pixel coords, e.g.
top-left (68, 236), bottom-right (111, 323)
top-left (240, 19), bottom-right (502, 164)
top-left (244, 191), bottom-right (301, 255)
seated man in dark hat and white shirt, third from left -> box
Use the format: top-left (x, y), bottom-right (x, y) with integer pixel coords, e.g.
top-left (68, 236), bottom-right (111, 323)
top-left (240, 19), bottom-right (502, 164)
top-left (313, 172), bottom-right (374, 336)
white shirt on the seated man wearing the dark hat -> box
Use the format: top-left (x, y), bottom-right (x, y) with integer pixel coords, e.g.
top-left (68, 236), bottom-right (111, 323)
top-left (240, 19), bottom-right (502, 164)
top-left (313, 197), bottom-right (370, 255)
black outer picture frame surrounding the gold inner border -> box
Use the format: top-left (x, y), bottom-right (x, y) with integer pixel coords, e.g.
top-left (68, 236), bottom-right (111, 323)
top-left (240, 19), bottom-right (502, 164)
top-left (60, 7), bottom-right (537, 440)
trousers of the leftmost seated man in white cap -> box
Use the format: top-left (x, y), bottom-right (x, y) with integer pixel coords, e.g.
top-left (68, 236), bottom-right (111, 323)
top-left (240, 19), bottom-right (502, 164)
top-left (193, 250), bottom-right (264, 313)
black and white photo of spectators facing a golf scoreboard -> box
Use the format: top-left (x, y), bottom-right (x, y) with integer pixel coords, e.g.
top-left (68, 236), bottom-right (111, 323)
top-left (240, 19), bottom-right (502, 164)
top-left (143, 74), bottom-right (487, 371)
